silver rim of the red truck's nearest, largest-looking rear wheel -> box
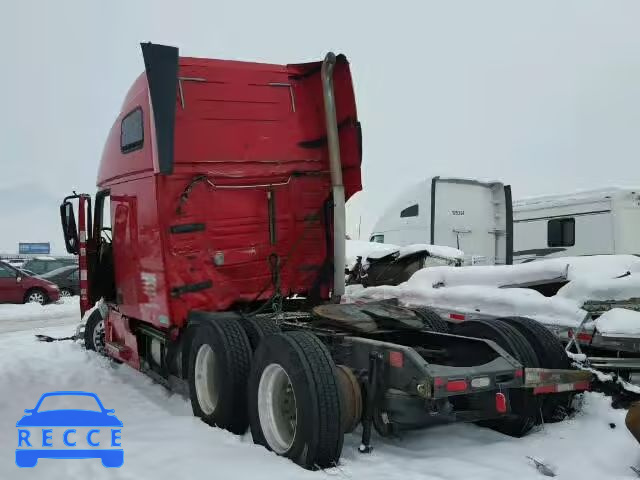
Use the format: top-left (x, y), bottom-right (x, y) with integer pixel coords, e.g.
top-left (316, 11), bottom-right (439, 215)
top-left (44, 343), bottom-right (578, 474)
top-left (258, 363), bottom-right (298, 455)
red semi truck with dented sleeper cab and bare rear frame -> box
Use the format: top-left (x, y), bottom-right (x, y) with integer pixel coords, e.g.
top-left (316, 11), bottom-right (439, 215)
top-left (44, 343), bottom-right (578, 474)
top-left (60, 43), bottom-right (589, 468)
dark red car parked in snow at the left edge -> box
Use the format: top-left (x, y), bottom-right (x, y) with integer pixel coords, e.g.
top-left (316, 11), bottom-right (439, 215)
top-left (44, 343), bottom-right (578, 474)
top-left (0, 261), bottom-right (60, 305)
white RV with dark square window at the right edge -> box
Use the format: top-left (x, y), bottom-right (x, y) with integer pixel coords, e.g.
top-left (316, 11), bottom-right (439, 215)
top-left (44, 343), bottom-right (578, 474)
top-left (513, 188), bottom-right (640, 263)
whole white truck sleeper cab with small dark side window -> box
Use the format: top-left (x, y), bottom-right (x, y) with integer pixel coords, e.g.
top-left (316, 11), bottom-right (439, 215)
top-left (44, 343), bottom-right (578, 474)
top-left (370, 177), bottom-right (513, 265)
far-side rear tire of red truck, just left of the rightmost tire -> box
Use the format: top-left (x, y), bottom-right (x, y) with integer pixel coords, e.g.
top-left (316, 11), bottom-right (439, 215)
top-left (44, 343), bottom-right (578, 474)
top-left (454, 320), bottom-right (541, 437)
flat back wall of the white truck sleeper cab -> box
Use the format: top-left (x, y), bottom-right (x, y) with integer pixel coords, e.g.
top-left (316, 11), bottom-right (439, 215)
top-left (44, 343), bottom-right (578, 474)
top-left (431, 178), bottom-right (512, 265)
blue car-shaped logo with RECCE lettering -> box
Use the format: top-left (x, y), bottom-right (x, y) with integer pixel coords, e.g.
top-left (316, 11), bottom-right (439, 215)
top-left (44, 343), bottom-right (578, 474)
top-left (16, 392), bottom-right (124, 468)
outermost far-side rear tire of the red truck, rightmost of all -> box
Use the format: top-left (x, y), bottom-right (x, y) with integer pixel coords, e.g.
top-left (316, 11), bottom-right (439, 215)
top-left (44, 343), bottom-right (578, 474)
top-left (497, 317), bottom-right (574, 423)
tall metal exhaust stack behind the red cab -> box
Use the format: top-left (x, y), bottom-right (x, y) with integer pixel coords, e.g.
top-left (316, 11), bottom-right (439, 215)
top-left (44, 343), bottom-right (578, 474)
top-left (321, 52), bottom-right (346, 303)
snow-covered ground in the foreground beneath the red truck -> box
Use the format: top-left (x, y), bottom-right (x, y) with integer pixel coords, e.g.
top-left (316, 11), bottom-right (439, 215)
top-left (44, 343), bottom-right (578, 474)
top-left (0, 299), bottom-right (640, 480)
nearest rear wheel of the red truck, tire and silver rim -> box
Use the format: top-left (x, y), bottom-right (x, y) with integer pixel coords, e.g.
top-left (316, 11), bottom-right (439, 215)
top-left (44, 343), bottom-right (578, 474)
top-left (249, 332), bottom-right (343, 469)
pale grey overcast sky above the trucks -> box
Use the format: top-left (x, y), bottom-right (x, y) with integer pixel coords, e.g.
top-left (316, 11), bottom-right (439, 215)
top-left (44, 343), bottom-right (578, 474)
top-left (0, 0), bottom-right (640, 252)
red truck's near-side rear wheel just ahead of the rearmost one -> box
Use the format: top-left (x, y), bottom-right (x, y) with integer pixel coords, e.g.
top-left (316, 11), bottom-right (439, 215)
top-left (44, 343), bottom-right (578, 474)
top-left (189, 318), bottom-right (251, 435)
